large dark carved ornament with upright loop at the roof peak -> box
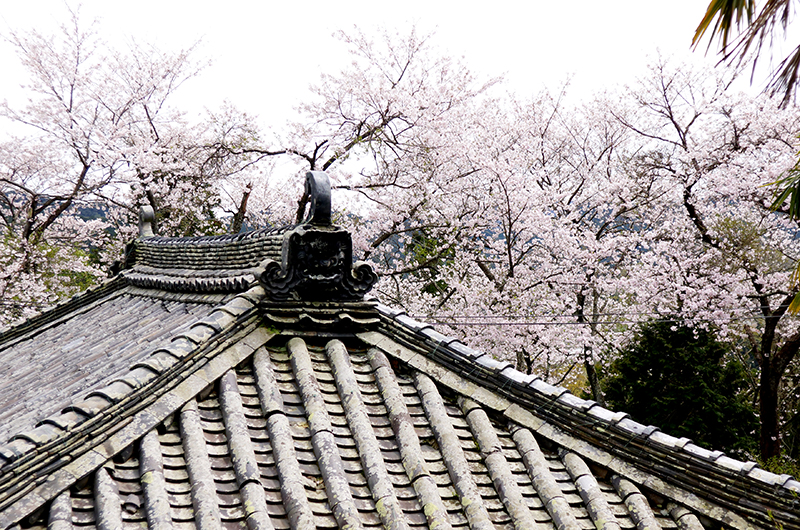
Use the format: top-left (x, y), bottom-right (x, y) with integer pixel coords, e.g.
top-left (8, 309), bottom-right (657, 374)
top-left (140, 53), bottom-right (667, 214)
top-left (259, 171), bottom-right (378, 301)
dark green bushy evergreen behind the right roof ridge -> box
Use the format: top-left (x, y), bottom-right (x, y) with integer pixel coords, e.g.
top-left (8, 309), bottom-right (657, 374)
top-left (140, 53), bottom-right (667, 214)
top-left (602, 321), bottom-right (758, 454)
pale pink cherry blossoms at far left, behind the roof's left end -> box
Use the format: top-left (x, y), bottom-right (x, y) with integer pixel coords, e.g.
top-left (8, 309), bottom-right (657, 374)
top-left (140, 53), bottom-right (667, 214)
top-left (0, 11), bottom-right (257, 322)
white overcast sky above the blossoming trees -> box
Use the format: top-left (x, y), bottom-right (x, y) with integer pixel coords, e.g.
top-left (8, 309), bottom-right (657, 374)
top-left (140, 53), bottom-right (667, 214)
top-left (0, 0), bottom-right (776, 130)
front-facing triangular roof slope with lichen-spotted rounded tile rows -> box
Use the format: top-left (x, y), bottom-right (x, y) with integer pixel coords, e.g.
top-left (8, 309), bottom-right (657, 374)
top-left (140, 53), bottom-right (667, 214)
top-left (5, 332), bottom-right (750, 530)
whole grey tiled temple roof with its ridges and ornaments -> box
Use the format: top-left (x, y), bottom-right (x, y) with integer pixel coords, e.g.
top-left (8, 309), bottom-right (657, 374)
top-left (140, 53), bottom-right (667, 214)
top-left (0, 173), bottom-right (800, 530)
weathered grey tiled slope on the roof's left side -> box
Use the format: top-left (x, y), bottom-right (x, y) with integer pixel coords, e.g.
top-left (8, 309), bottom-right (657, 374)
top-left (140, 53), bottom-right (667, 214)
top-left (0, 294), bottom-right (213, 442)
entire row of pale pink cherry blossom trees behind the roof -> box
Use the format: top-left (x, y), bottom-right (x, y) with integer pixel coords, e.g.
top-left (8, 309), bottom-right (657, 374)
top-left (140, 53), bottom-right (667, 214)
top-left (6, 14), bottom-right (800, 457)
